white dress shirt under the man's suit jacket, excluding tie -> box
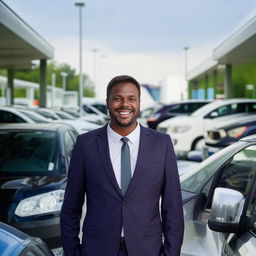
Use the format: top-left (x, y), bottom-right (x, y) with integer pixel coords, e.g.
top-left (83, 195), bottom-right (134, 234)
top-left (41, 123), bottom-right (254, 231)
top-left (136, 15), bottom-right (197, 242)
top-left (107, 123), bottom-right (140, 188)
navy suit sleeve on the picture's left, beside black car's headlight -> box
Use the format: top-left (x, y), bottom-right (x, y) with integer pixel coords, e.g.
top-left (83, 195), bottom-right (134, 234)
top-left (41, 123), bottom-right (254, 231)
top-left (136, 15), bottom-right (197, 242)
top-left (60, 136), bottom-right (85, 256)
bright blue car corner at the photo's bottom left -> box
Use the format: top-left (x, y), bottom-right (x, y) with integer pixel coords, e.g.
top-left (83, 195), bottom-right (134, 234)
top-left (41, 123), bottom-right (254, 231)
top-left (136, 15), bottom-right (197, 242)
top-left (0, 222), bottom-right (54, 256)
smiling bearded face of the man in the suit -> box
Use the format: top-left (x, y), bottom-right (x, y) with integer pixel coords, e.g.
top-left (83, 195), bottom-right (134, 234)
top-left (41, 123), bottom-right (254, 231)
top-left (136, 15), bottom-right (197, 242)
top-left (107, 82), bottom-right (140, 127)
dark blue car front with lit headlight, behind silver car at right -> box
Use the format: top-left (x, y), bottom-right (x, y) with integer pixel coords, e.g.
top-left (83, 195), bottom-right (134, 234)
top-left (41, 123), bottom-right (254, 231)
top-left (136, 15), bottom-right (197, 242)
top-left (205, 114), bottom-right (256, 154)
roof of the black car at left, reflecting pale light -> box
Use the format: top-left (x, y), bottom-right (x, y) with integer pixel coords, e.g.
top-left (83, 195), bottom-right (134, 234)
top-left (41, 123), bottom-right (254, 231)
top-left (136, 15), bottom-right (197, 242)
top-left (0, 123), bottom-right (72, 131)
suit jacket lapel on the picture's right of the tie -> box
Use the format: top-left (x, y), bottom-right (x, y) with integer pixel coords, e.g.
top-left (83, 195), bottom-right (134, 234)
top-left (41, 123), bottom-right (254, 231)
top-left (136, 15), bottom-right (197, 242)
top-left (125, 126), bottom-right (150, 198)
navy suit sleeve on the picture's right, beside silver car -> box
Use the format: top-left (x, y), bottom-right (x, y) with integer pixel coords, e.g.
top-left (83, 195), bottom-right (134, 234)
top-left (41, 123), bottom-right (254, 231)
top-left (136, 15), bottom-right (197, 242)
top-left (161, 137), bottom-right (184, 256)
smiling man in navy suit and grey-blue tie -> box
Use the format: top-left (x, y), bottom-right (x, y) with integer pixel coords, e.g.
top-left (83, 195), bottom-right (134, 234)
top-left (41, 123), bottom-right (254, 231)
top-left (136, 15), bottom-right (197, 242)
top-left (61, 76), bottom-right (184, 256)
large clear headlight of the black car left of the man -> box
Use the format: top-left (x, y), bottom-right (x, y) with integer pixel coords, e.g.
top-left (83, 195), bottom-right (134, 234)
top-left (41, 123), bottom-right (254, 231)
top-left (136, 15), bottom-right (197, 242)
top-left (15, 189), bottom-right (65, 217)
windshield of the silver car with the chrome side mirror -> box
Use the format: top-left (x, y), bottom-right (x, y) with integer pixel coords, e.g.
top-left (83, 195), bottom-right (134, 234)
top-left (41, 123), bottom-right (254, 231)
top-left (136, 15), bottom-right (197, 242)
top-left (180, 141), bottom-right (248, 193)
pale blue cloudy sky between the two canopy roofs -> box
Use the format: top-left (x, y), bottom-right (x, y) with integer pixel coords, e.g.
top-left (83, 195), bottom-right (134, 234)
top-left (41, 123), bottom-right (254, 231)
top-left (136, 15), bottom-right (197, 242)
top-left (4, 0), bottom-right (256, 97)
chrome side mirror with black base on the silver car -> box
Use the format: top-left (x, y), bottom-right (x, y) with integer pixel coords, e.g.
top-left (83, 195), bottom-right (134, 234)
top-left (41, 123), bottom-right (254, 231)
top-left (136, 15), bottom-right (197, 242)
top-left (208, 188), bottom-right (245, 233)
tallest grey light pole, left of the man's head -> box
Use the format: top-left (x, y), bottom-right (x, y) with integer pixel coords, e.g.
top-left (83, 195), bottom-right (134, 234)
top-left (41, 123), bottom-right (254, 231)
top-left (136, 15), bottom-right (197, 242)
top-left (75, 2), bottom-right (85, 116)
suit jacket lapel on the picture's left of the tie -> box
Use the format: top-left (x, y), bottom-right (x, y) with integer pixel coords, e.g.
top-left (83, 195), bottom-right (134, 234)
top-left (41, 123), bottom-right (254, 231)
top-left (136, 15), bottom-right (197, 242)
top-left (97, 126), bottom-right (123, 197)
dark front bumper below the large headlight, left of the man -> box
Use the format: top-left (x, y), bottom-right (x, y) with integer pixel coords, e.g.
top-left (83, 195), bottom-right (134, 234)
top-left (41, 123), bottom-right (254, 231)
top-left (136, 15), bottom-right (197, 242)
top-left (11, 217), bottom-right (61, 249)
